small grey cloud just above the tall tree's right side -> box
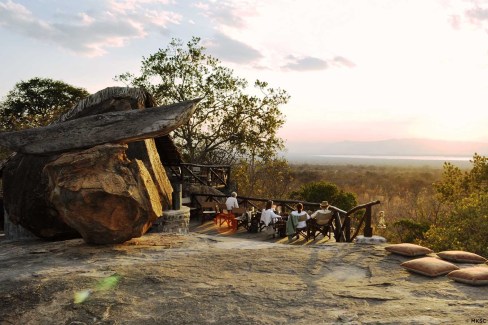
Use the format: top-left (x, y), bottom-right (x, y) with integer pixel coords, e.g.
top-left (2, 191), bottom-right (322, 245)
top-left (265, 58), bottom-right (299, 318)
top-left (205, 33), bottom-right (262, 64)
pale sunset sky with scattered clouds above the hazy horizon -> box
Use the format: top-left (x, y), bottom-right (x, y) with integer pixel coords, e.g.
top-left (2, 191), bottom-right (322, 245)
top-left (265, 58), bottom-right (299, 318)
top-left (0, 0), bottom-right (488, 151)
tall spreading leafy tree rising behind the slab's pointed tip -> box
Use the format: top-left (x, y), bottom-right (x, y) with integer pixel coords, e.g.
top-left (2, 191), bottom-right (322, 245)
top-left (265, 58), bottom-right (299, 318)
top-left (115, 37), bottom-right (289, 164)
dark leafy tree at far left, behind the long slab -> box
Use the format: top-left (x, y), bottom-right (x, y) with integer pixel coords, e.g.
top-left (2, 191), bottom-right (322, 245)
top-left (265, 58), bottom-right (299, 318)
top-left (0, 77), bottom-right (89, 131)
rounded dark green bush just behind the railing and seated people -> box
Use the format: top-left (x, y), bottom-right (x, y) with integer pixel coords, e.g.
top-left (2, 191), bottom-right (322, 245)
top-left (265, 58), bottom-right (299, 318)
top-left (290, 181), bottom-right (357, 211)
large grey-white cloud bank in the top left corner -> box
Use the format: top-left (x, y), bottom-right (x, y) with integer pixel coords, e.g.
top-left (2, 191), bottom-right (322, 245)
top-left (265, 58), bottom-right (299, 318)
top-left (0, 0), bottom-right (181, 57)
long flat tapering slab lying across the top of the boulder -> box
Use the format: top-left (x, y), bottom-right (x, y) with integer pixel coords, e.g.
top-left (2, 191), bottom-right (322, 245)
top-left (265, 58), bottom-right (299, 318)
top-left (0, 99), bottom-right (200, 154)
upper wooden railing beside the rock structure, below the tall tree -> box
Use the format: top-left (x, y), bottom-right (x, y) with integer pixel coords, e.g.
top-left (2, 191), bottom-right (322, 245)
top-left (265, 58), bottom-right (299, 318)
top-left (167, 163), bottom-right (230, 190)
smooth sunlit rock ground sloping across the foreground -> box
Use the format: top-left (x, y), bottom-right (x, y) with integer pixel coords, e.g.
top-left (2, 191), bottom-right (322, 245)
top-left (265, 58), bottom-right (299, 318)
top-left (0, 222), bottom-right (488, 324)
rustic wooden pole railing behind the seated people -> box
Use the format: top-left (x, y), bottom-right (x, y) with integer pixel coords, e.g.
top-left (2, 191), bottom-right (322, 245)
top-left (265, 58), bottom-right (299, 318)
top-left (192, 193), bottom-right (380, 243)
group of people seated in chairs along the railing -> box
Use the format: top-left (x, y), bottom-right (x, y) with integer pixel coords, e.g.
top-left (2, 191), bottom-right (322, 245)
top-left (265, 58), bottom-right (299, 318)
top-left (225, 192), bottom-right (330, 240)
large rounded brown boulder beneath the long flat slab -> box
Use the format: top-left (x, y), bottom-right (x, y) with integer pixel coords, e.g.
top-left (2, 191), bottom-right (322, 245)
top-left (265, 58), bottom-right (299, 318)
top-left (44, 144), bottom-right (163, 244)
